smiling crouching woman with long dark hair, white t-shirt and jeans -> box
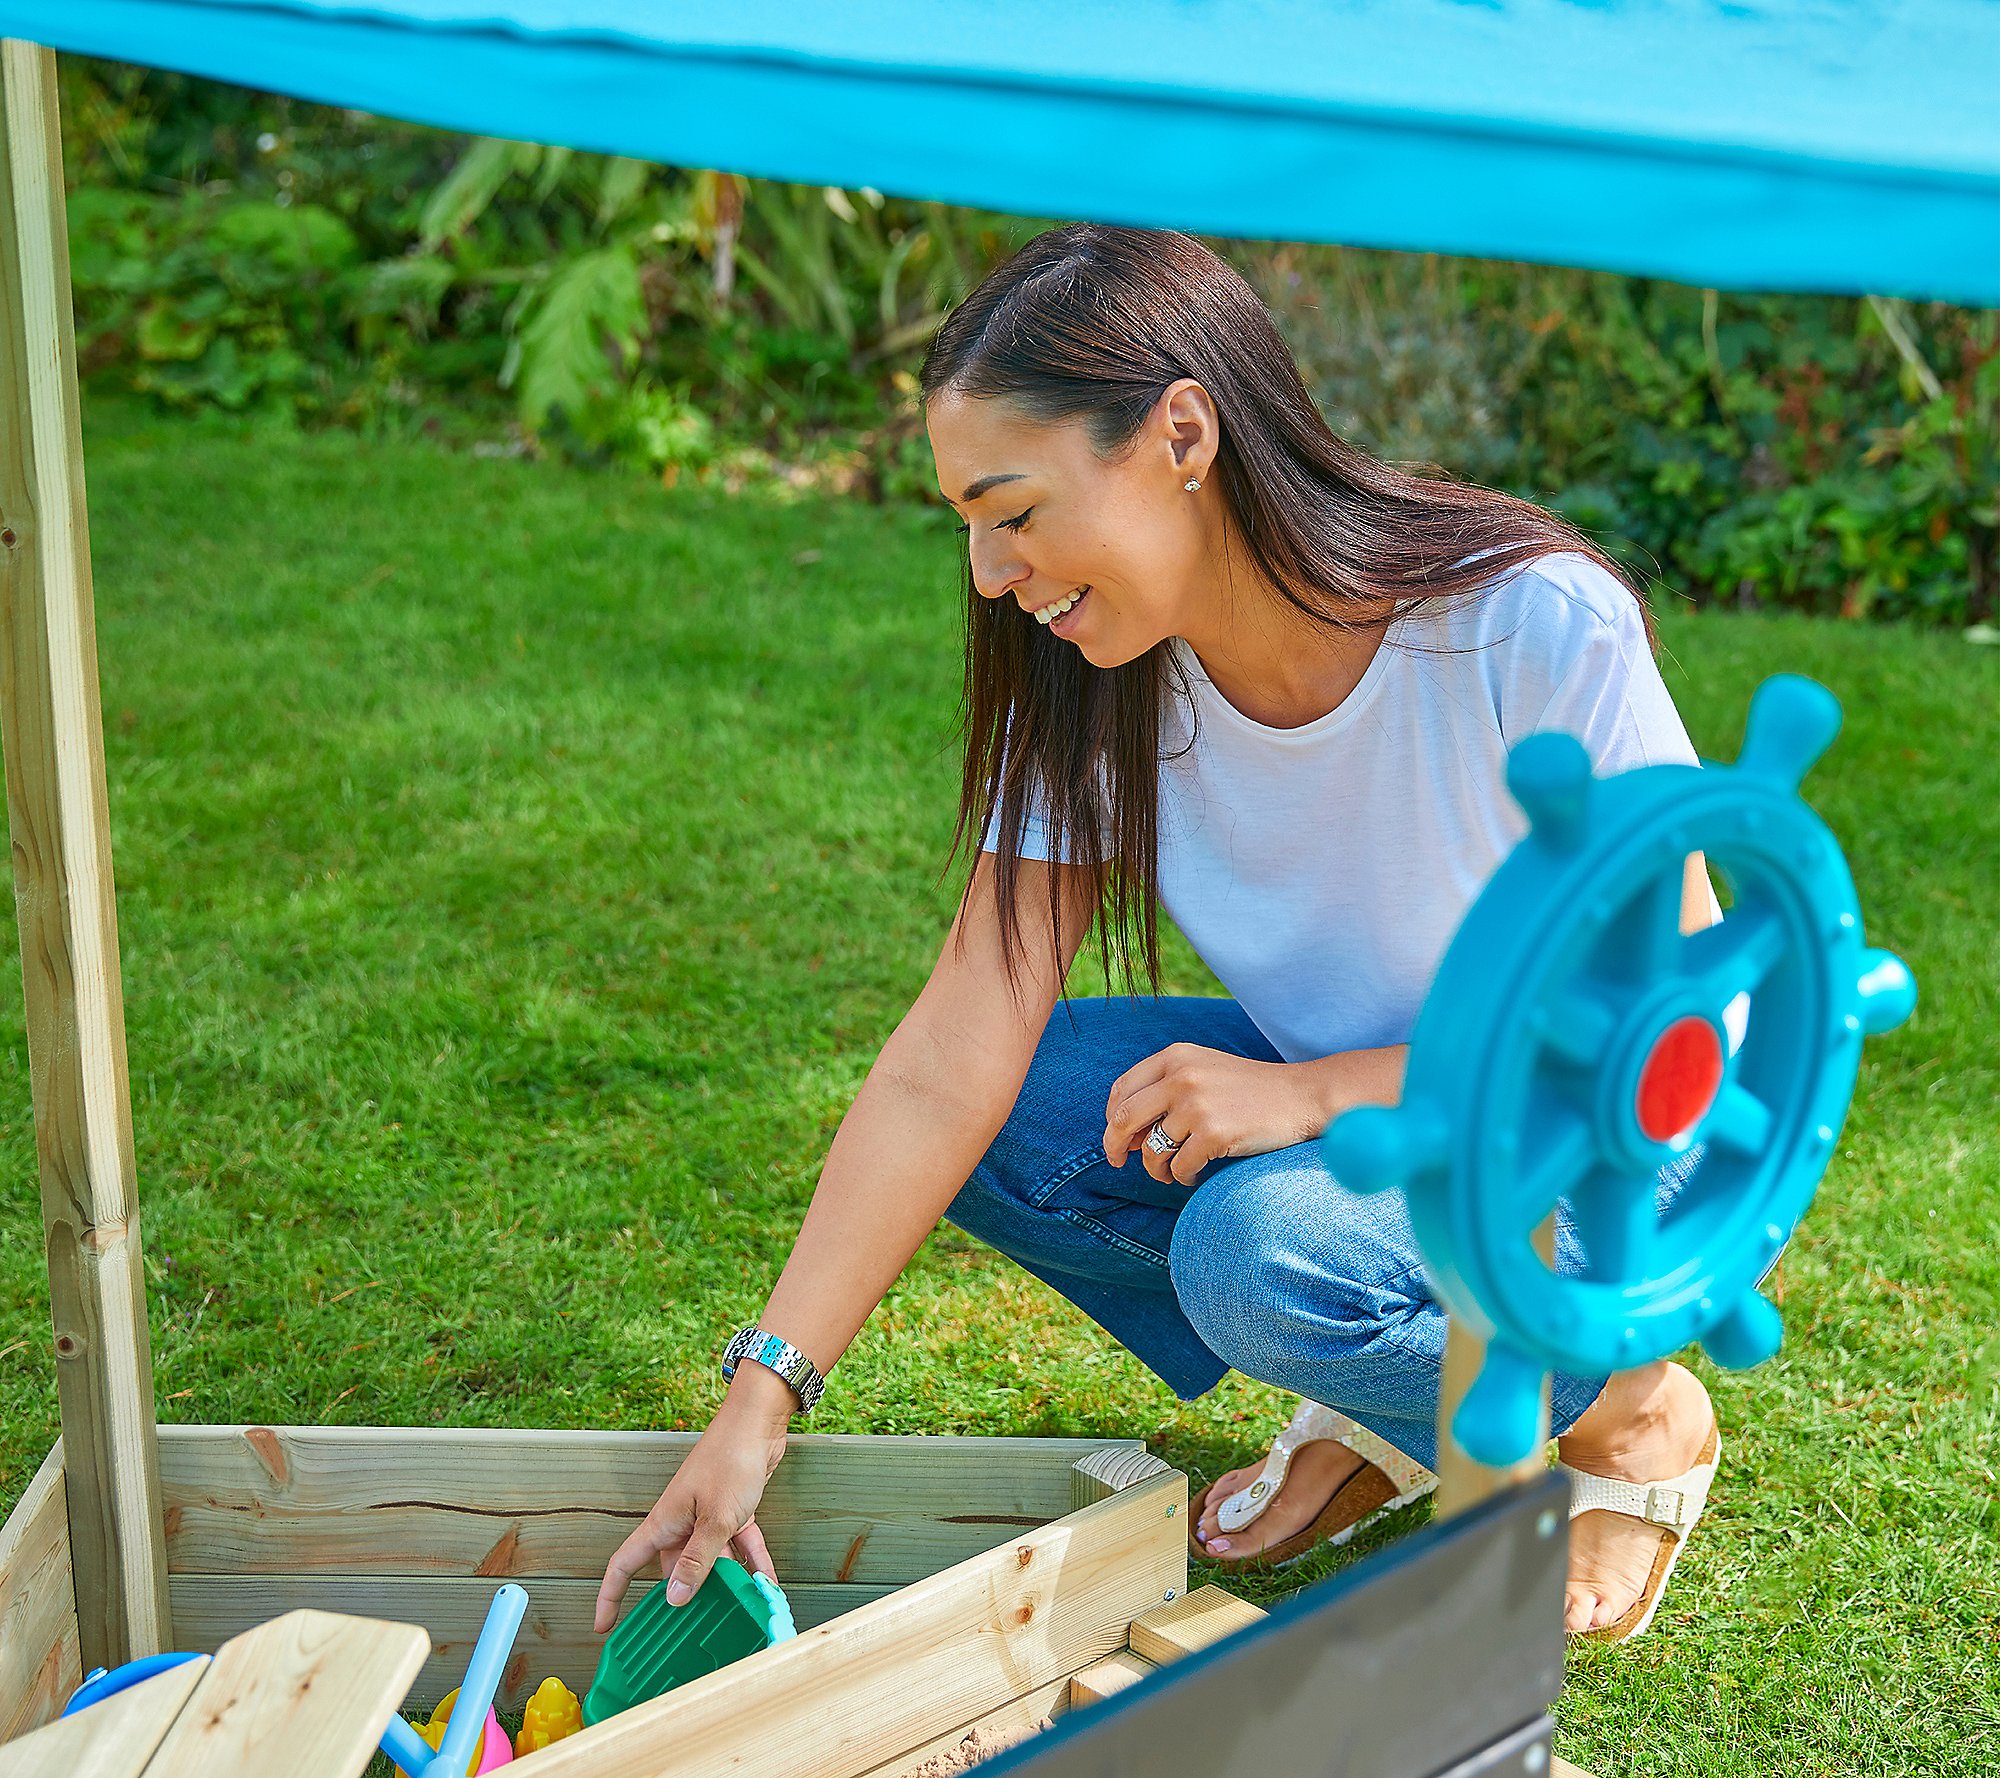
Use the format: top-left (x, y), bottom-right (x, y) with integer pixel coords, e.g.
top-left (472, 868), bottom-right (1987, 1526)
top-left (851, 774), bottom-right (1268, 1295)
top-left (598, 224), bottom-right (1716, 1638)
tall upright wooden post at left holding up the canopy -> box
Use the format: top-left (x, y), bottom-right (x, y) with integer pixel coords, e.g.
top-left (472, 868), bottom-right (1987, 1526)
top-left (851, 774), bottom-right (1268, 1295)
top-left (0, 40), bottom-right (168, 1668)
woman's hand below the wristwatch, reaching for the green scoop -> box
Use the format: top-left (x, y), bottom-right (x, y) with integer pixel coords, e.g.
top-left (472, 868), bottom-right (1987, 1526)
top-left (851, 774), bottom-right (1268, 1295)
top-left (594, 1364), bottom-right (798, 1636)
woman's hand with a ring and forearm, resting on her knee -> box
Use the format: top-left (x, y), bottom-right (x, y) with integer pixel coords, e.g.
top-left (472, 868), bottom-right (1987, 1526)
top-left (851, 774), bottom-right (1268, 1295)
top-left (1104, 1044), bottom-right (1408, 1186)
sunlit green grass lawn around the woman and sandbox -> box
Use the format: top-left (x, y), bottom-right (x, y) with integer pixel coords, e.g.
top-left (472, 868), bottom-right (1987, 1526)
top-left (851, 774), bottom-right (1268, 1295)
top-left (0, 414), bottom-right (2000, 1778)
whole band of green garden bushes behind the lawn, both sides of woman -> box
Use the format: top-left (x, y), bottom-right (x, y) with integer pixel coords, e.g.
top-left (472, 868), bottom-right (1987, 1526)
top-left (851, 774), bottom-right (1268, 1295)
top-left (64, 60), bottom-right (2000, 624)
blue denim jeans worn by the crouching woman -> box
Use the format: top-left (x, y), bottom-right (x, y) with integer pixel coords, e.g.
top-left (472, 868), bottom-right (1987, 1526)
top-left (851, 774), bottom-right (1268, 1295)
top-left (946, 996), bottom-right (1696, 1468)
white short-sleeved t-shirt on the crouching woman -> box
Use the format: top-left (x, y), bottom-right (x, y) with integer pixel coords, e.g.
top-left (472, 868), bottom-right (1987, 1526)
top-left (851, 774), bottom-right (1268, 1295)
top-left (984, 552), bottom-right (1712, 1062)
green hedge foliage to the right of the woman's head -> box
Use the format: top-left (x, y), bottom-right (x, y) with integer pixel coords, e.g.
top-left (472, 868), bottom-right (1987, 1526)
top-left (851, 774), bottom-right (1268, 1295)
top-left (1236, 246), bottom-right (2000, 624)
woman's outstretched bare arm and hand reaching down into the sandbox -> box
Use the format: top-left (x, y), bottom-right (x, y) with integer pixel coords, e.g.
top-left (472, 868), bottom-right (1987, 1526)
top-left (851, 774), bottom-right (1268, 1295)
top-left (596, 852), bottom-right (1094, 1632)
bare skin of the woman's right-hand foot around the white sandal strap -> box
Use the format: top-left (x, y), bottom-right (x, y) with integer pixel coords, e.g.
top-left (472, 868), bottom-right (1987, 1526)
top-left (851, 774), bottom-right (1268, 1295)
top-left (1552, 1360), bottom-right (1716, 1632)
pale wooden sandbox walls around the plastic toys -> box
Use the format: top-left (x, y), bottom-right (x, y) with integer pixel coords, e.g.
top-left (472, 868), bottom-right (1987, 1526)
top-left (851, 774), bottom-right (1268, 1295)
top-left (0, 1426), bottom-right (1192, 1778)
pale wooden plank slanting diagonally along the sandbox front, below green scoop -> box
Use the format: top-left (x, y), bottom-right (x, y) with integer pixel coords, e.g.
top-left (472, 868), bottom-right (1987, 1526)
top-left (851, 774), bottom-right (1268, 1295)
top-left (514, 1470), bottom-right (1188, 1778)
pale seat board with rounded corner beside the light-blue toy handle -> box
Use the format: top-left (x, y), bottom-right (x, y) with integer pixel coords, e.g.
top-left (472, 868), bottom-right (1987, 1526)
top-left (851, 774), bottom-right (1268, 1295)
top-left (146, 1612), bottom-right (430, 1778)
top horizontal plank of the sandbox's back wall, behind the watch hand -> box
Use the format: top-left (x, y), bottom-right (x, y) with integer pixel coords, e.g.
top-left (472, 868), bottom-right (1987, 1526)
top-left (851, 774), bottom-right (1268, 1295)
top-left (160, 1426), bottom-right (1158, 1586)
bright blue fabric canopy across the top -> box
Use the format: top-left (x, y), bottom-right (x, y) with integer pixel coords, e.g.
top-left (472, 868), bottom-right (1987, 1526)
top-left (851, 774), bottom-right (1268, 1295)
top-left (0, 0), bottom-right (2000, 304)
